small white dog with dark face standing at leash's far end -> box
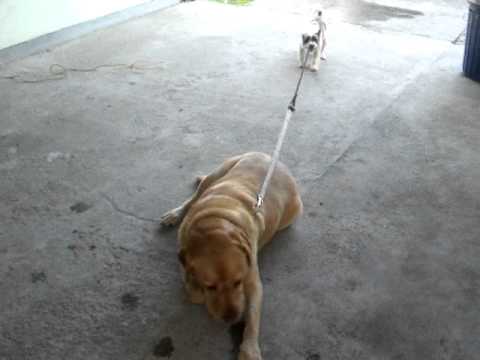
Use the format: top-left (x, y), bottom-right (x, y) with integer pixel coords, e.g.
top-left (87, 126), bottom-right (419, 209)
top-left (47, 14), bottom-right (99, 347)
top-left (299, 11), bottom-right (327, 71)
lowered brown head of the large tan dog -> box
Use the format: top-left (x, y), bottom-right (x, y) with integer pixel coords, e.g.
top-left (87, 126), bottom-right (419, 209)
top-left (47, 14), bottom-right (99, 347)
top-left (179, 232), bottom-right (250, 323)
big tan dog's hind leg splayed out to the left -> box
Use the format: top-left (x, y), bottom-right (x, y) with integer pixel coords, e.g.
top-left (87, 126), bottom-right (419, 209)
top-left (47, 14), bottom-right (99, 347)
top-left (160, 156), bottom-right (244, 226)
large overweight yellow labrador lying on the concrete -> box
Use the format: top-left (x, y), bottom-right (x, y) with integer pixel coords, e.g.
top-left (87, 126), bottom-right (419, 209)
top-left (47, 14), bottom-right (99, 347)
top-left (161, 152), bottom-right (302, 360)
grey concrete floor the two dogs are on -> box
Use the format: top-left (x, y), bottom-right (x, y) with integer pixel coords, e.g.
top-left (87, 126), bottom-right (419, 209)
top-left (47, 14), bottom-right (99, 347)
top-left (0, 0), bottom-right (480, 360)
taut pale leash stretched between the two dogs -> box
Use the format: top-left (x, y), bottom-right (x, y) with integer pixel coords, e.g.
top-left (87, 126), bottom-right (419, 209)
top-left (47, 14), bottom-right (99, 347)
top-left (255, 49), bottom-right (311, 212)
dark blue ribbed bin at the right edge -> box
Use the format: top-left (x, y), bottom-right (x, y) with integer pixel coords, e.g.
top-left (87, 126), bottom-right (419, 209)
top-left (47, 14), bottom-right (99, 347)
top-left (463, 0), bottom-right (480, 81)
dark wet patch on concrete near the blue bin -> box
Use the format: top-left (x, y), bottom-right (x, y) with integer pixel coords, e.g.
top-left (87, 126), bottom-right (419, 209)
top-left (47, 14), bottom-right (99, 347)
top-left (346, 0), bottom-right (424, 24)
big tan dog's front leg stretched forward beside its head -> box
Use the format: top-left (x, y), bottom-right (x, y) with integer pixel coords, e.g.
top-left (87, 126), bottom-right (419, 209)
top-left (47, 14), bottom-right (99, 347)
top-left (238, 260), bottom-right (263, 360)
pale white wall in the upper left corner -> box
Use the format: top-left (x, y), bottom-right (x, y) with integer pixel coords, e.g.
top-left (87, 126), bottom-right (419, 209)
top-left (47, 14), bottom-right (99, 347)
top-left (0, 0), bottom-right (149, 49)
